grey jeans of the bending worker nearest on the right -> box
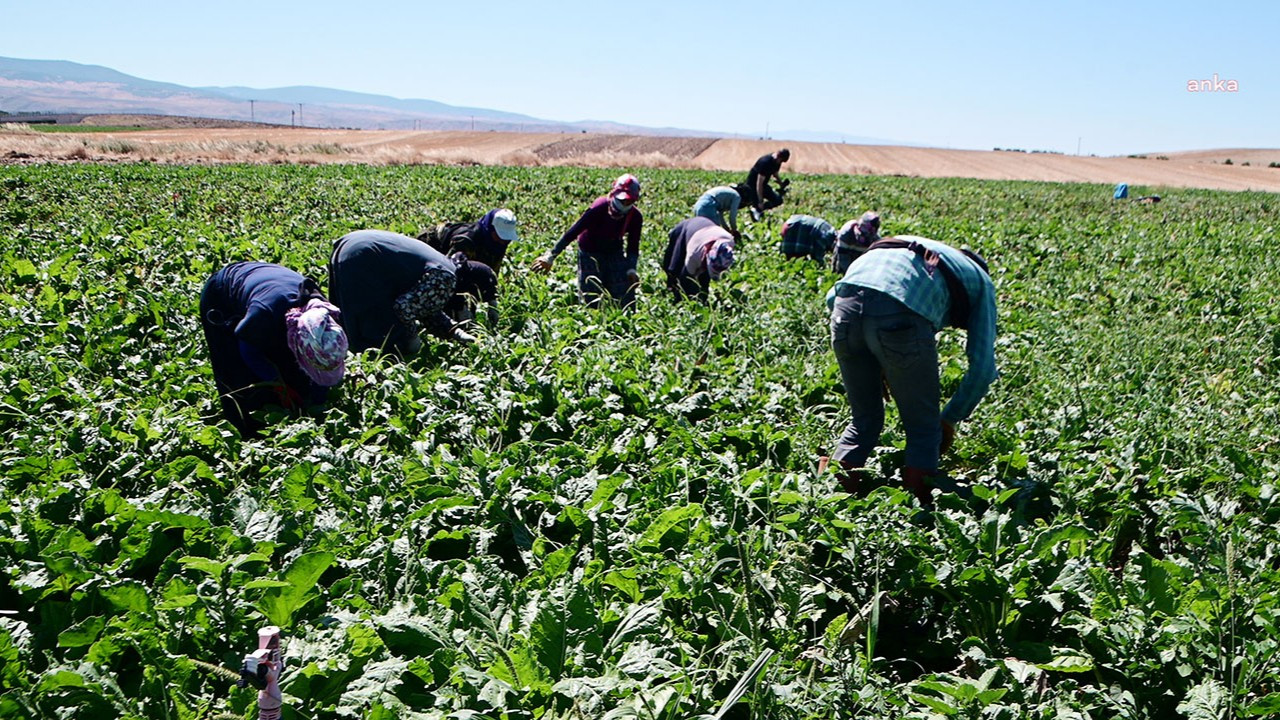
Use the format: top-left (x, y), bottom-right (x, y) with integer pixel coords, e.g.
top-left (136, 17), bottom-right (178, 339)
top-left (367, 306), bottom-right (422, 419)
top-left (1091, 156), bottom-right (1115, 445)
top-left (831, 288), bottom-right (942, 470)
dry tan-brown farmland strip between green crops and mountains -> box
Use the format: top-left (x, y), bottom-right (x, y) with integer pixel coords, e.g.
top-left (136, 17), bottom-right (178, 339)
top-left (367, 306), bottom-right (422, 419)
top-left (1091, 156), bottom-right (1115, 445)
top-left (0, 119), bottom-right (1280, 192)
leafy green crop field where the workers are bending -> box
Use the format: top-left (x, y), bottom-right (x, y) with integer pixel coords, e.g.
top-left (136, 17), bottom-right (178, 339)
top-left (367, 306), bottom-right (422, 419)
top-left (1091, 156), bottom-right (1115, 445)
top-left (0, 164), bottom-right (1280, 720)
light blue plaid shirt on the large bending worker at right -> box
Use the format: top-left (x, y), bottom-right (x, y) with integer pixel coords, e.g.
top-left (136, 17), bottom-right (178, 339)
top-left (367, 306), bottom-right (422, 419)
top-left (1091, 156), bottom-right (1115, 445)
top-left (827, 234), bottom-right (997, 424)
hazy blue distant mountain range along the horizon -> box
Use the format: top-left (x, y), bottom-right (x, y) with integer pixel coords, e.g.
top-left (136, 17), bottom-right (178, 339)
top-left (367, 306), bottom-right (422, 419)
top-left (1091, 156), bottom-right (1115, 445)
top-left (0, 58), bottom-right (904, 145)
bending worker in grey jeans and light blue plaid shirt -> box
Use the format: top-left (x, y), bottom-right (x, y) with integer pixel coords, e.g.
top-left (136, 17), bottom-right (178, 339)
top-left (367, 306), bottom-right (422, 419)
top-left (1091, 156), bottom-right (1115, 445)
top-left (827, 236), bottom-right (996, 505)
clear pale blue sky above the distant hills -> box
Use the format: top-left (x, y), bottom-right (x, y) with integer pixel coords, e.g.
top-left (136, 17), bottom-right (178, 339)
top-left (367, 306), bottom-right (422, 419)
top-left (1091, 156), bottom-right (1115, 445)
top-left (0, 0), bottom-right (1280, 155)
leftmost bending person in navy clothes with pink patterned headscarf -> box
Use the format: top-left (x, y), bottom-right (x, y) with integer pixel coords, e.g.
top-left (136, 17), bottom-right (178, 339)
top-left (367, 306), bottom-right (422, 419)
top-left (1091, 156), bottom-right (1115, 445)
top-left (200, 263), bottom-right (347, 436)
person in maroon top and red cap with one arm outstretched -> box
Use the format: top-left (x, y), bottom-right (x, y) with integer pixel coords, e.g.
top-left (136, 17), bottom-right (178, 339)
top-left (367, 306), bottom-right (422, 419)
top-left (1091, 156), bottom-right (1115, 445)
top-left (532, 174), bottom-right (643, 307)
